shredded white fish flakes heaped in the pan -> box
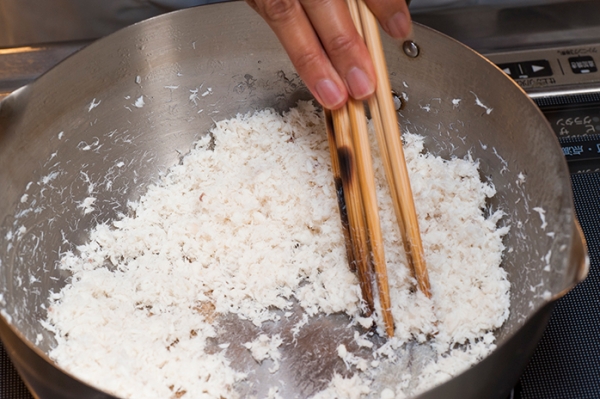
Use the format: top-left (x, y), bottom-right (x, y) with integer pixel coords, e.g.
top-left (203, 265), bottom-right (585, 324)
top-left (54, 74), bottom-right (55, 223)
top-left (47, 102), bottom-right (510, 399)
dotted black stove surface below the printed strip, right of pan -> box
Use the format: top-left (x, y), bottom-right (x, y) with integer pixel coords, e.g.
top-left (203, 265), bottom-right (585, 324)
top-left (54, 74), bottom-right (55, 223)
top-left (517, 172), bottom-right (600, 399)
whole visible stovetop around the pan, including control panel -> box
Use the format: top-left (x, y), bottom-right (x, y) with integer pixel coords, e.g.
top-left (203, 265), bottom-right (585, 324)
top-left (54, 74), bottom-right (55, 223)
top-left (0, 0), bottom-right (600, 399)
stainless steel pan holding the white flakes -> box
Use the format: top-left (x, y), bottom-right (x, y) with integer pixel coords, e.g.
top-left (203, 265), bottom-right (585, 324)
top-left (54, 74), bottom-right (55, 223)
top-left (0, 3), bottom-right (588, 399)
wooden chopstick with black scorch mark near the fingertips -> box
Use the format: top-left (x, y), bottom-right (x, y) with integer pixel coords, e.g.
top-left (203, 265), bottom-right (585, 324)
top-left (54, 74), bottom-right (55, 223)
top-left (332, 106), bottom-right (375, 316)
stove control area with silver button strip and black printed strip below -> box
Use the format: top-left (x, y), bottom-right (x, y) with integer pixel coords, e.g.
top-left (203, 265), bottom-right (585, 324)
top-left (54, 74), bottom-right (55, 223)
top-left (485, 43), bottom-right (600, 173)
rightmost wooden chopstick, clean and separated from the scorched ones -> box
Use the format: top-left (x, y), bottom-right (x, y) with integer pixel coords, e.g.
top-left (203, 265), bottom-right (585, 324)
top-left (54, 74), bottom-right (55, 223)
top-left (350, 0), bottom-right (431, 297)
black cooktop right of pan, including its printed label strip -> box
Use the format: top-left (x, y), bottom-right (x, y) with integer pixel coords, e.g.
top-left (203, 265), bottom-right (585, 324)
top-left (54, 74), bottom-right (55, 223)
top-left (514, 94), bottom-right (600, 399)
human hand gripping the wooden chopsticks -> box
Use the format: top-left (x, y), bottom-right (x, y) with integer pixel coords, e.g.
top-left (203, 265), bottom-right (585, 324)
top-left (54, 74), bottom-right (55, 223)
top-left (246, 0), bottom-right (412, 109)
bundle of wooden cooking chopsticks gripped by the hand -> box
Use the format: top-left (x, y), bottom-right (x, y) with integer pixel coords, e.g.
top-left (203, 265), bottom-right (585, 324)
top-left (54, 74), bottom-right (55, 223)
top-left (325, 0), bottom-right (431, 337)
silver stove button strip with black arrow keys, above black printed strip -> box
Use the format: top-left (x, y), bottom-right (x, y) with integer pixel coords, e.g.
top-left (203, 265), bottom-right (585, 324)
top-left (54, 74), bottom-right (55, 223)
top-left (484, 43), bottom-right (600, 93)
